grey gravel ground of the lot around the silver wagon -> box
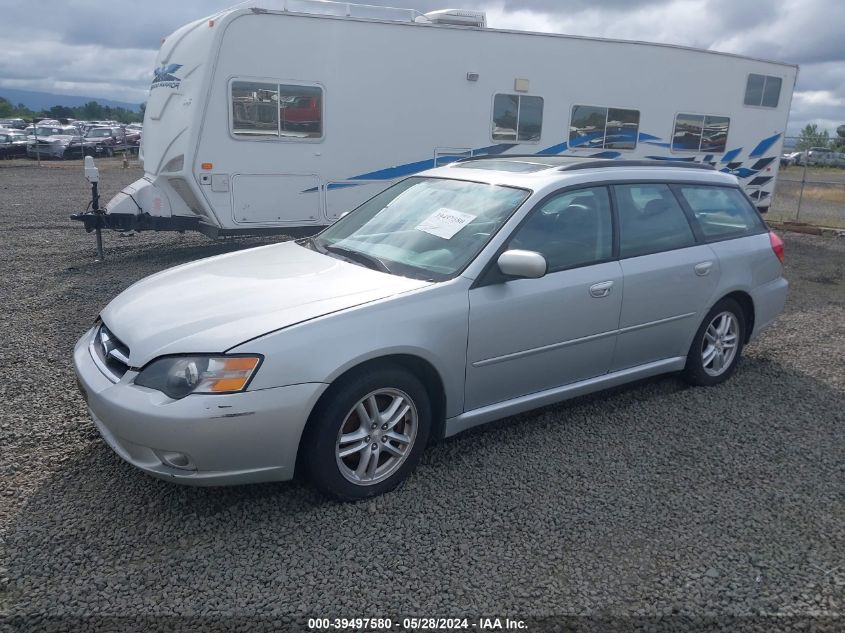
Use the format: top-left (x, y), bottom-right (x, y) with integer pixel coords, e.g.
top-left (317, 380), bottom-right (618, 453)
top-left (0, 167), bottom-right (845, 631)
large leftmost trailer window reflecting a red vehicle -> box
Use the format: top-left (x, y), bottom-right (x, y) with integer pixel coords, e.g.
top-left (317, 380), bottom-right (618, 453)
top-left (232, 81), bottom-right (323, 139)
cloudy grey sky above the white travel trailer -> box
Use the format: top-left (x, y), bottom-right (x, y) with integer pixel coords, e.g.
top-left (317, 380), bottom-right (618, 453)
top-left (0, 0), bottom-right (845, 133)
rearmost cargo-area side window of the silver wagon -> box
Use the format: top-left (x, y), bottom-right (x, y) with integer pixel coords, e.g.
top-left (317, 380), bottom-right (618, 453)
top-left (678, 185), bottom-right (763, 239)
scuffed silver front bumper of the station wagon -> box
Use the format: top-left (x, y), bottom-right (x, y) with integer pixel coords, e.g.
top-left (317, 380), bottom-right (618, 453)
top-left (74, 329), bottom-right (327, 486)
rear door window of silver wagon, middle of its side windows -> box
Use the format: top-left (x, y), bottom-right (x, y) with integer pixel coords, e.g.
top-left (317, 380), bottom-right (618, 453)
top-left (614, 184), bottom-right (695, 257)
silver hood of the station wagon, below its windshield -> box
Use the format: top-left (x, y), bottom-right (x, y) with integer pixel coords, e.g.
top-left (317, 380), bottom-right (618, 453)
top-left (101, 242), bottom-right (431, 368)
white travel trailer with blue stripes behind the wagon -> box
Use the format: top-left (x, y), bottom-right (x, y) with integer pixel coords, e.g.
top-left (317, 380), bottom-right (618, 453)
top-left (74, 0), bottom-right (797, 237)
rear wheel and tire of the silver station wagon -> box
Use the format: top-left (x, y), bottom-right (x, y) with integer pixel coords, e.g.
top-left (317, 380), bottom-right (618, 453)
top-left (684, 299), bottom-right (745, 386)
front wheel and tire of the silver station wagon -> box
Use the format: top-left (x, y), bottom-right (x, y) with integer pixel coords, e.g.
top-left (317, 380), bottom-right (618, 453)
top-left (300, 366), bottom-right (431, 501)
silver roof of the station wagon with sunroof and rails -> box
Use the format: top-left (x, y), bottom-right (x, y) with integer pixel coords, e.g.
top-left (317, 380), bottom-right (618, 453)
top-left (419, 154), bottom-right (738, 192)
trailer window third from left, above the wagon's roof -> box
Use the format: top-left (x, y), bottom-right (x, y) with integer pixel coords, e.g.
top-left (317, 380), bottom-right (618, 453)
top-left (569, 105), bottom-right (640, 149)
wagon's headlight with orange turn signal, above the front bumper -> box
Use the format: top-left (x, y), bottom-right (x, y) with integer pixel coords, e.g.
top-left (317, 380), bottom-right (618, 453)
top-left (135, 356), bottom-right (261, 400)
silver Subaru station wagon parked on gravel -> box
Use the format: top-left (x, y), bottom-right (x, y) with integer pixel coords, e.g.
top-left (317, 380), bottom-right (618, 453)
top-left (74, 156), bottom-right (787, 500)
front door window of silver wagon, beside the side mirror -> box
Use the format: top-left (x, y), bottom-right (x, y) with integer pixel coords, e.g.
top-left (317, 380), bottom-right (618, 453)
top-left (510, 187), bottom-right (613, 273)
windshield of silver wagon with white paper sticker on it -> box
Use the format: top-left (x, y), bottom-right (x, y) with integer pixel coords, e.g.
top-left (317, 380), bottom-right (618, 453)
top-left (309, 177), bottom-right (530, 281)
